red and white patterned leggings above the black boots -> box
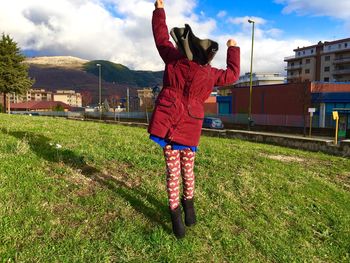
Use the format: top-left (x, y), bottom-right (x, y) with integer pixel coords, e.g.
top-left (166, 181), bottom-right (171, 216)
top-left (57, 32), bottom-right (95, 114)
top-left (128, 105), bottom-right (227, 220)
top-left (164, 145), bottom-right (196, 209)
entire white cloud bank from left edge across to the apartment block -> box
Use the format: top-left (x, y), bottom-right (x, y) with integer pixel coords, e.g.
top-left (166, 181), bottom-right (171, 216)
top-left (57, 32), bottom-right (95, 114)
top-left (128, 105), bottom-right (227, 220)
top-left (0, 0), bottom-right (316, 73)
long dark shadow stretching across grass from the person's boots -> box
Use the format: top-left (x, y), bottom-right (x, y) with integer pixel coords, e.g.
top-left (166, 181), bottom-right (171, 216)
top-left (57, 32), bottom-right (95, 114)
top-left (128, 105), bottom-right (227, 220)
top-left (0, 128), bottom-right (171, 233)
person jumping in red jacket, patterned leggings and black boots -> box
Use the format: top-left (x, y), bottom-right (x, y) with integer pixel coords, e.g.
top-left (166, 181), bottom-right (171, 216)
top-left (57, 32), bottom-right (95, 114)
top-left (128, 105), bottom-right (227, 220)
top-left (148, 0), bottom-right (240, 238)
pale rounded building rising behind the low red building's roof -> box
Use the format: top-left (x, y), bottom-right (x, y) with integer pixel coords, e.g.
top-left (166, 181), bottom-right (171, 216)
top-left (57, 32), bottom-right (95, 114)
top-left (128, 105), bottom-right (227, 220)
top-left (234, 72), bottom-right (285, 87)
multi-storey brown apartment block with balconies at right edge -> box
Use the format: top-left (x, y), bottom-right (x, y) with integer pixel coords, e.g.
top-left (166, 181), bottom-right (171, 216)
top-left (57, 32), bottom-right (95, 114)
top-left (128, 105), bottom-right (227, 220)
top-left (284, 38), bottom-right (350, 83)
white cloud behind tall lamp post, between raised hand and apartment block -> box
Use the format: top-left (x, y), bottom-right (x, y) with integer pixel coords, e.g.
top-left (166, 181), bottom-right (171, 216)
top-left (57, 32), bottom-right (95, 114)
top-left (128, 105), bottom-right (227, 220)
top-left (213, 16), bottom-right (316, 75)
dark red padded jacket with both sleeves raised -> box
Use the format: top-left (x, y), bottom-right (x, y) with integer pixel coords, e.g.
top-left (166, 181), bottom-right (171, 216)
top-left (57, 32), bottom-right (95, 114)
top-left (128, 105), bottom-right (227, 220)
top-left (148, 8), bottom-right (240, 146)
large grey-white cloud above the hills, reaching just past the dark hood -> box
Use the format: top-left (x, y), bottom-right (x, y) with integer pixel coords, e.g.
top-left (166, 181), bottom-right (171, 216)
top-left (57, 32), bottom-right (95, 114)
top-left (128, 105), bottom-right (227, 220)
top-left (0, 0), bottom-right (216, 70)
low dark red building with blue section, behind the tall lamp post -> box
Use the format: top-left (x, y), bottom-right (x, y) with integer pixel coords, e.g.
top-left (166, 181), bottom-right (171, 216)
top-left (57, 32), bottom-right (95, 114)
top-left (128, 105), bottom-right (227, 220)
top-left (217, 83), bottom-right (311, 127)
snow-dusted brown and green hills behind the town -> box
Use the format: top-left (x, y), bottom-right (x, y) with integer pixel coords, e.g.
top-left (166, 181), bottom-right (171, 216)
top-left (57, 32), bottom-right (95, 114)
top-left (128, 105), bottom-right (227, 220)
top-left (25, 56), bottom-right (163, 102)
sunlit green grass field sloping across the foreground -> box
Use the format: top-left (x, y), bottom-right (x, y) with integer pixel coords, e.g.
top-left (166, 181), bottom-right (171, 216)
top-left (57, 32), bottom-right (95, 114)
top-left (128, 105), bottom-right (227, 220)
top-left (0, 114), bottom-right (350, 262)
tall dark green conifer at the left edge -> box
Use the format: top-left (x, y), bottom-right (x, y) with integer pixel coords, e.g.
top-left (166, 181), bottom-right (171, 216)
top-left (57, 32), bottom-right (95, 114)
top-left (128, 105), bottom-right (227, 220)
top-left (0, 34), bottom-right (34, 110)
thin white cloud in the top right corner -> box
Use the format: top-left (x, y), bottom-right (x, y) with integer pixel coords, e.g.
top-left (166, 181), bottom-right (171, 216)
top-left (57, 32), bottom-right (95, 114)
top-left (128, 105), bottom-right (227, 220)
top-left (275, 0), bottom-right (350, 20)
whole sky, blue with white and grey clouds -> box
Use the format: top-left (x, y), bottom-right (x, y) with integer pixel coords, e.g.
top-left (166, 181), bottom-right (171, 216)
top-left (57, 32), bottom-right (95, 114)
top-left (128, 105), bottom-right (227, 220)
top-left (0, 0), bottom-right (350, 74)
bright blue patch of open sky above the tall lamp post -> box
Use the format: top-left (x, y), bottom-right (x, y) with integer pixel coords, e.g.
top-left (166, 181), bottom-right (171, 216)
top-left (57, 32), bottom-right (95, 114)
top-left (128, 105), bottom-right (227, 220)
top-left (196, 0), bottom-right (350, 40)
